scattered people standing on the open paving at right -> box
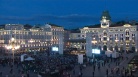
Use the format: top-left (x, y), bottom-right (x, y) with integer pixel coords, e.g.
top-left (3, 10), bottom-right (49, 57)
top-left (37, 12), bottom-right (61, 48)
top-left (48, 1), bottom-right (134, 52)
top-left (72, 53), bottom-right (133, 77)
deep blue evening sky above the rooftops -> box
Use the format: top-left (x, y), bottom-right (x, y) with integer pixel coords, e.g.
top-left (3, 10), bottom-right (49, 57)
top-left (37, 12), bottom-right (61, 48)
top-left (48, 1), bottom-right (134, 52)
top-left (0, 0), bottom-right (138, 29)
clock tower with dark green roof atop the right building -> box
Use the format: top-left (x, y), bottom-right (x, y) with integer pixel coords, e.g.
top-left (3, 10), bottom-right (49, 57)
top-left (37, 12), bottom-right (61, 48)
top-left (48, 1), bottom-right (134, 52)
top-left (100, 11), bottom-right (111, 28)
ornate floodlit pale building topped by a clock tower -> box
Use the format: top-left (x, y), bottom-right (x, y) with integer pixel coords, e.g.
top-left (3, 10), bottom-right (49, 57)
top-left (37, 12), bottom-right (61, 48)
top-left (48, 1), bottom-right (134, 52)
top-left (80, 11), bottom-right (138, 52)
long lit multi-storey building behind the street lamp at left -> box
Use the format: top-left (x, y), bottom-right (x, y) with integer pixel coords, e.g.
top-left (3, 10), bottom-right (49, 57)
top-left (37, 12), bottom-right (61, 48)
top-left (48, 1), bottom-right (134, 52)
top-left (0, 24), bottom-right (64, 52)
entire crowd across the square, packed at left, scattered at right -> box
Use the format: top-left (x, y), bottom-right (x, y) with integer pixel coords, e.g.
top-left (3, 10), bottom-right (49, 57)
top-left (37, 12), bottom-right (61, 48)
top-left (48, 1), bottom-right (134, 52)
top-left (0, 52), bottom-right (136, 77)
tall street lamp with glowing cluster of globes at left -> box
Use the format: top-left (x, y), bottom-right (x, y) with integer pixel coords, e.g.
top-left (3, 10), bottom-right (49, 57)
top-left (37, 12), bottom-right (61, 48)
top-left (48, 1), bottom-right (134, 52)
top-left (5, 37), bottom-right (20, 76)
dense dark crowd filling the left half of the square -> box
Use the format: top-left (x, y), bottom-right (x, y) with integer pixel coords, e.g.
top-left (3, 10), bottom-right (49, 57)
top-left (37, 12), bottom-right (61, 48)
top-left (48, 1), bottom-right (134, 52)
top-left (0, 52), bottom-right (77, 77)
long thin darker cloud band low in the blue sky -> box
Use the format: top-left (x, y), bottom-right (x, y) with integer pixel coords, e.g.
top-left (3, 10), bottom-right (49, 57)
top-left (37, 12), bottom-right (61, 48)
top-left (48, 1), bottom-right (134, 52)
top-left (0, 14), bottom-right (99, 23)
